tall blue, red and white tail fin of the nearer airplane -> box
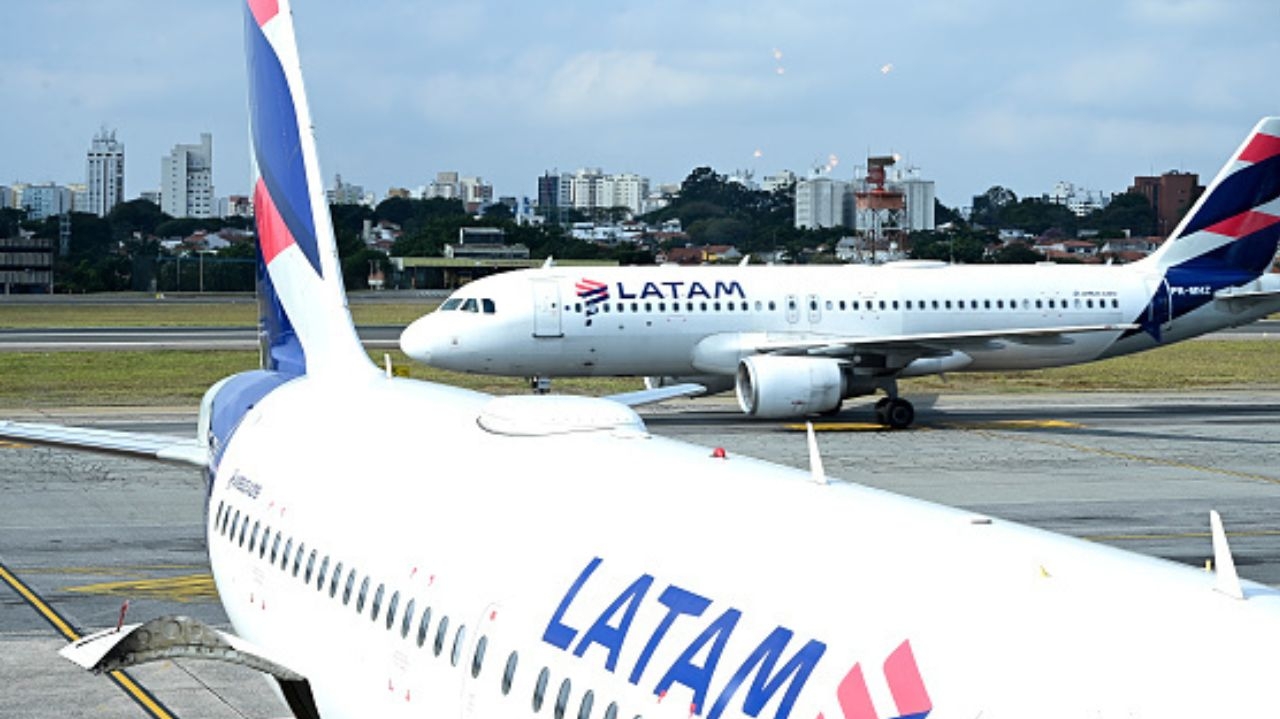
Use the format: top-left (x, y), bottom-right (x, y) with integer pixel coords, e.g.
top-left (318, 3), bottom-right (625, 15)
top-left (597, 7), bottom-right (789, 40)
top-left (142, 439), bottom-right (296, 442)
top-left (244, 0), bottom-right (376, 375)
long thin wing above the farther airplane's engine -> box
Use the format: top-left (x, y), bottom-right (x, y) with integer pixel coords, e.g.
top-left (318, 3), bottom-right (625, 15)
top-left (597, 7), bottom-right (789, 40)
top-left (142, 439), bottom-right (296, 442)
top-left (755, 324), bottom-right (1137, 357)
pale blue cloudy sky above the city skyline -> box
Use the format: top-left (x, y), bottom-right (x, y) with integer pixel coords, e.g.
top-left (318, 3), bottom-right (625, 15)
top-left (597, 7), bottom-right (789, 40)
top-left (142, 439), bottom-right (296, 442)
top-left (0, 0), bottom-right (1280, 207)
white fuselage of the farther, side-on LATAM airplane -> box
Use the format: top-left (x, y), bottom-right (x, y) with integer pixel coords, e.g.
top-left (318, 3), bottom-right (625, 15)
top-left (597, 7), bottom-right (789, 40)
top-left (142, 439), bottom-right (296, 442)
top-left (402, 262), bottom-right (1280, 376)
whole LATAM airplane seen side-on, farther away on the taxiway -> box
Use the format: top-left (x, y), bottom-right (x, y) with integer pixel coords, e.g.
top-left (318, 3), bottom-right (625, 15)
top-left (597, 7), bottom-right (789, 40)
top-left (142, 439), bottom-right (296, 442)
top-left (401, 124), bottom-right (1280, 429)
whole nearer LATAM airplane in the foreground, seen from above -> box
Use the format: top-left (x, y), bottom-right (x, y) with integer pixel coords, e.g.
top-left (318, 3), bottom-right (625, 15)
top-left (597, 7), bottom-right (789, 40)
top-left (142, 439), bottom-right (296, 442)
top-left (0, 0), bottom-right (1280, 719)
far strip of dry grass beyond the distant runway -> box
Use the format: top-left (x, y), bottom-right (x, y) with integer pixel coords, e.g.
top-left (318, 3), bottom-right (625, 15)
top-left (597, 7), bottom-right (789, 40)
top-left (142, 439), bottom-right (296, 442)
top-left (0, 299), bottom-right (438, 329)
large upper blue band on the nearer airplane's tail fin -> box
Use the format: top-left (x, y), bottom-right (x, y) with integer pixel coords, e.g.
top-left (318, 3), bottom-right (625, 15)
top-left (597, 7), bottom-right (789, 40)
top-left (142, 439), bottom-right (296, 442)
top-left (244, 6), bottom-right (324, 276)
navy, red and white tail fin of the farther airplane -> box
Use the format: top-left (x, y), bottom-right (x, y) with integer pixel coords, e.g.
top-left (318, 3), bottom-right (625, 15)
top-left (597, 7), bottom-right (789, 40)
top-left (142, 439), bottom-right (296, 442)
top-left (1148, 118), bottom-right (1280, 277)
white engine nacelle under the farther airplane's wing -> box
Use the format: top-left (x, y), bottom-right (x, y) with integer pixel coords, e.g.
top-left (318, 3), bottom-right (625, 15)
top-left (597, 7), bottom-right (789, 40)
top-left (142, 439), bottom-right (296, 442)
top-left (735, 354), bottom-right (846, 420)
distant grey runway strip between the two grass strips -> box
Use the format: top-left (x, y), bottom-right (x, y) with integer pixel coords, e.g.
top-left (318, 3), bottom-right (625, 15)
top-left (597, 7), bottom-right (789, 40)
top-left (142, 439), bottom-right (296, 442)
top-left (0, 320), bottom-right (1280, 352)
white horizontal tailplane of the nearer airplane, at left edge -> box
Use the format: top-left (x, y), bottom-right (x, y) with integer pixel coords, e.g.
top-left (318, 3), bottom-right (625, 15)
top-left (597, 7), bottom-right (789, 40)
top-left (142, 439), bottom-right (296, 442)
top-left (0, 420), bottom-right (209, 467)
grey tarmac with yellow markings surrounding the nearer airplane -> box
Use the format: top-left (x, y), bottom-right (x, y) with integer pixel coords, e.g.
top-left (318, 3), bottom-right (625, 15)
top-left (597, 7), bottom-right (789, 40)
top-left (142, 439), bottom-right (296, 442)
top-left (0, 391), bottom-right (1280, 718)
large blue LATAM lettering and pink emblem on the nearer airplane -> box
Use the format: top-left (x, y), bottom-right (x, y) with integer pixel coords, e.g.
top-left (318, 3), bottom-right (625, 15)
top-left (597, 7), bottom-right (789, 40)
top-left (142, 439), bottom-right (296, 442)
top-left (543, 557), bottom-right (932, 719)
